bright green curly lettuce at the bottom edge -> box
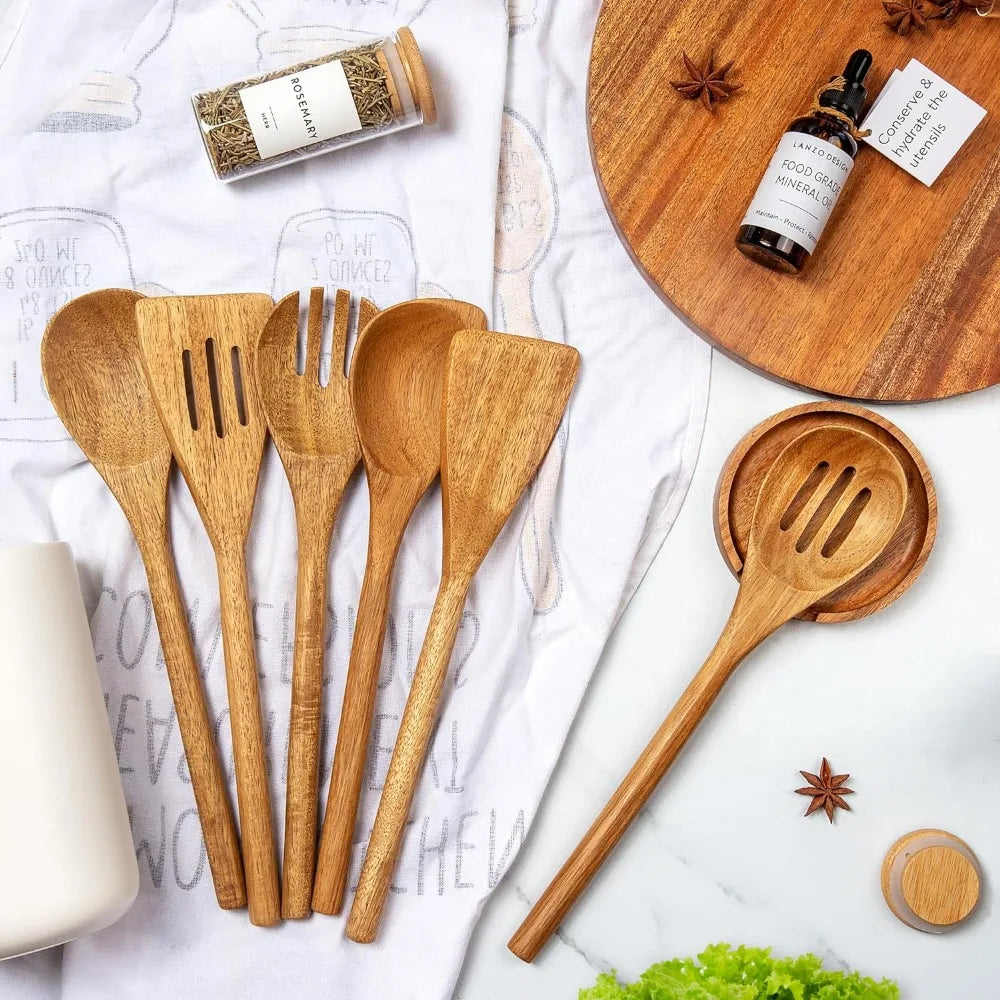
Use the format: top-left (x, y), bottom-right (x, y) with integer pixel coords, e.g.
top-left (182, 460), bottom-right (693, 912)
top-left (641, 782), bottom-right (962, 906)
top-left (579, 944), bottom-right (899, 1000)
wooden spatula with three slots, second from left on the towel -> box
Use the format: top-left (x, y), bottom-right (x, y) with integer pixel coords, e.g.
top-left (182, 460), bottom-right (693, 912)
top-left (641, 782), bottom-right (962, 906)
top-left (135, 294), bottom-right (281, 926)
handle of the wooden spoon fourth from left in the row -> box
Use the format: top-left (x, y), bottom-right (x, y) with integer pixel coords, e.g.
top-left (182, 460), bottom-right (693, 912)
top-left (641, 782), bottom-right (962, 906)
top-left (313, 538), bottom-right (395, 913)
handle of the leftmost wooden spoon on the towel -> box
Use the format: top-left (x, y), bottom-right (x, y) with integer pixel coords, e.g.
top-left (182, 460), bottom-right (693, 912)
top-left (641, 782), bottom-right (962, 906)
top-left (136, 521), bottom-right (247, 910)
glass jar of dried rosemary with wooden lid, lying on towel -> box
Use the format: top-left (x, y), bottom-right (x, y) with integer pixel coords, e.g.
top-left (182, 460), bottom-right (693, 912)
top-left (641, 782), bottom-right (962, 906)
top-left (191, 28), bottom-right (437, 181)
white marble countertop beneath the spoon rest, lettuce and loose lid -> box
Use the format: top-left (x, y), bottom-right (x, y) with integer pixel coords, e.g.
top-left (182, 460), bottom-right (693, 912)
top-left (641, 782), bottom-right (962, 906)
top-left (455, 354), bottom-right (1000, 1000)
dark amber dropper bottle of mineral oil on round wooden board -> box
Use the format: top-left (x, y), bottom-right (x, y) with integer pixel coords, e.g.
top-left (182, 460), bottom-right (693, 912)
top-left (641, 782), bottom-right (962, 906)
top-left (736, 49), bottom-right (872, 274)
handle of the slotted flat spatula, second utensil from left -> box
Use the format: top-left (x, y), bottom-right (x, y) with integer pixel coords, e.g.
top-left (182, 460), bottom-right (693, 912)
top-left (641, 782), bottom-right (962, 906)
top-left (216, 541), bottom-right (281, 927)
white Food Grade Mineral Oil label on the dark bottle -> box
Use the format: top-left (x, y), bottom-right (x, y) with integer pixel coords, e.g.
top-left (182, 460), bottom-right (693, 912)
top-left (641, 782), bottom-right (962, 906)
top-left (743, 132), bottom-right (854, 253)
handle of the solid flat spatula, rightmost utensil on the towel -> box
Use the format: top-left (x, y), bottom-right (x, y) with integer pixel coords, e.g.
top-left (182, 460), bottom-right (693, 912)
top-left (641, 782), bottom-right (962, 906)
top-left (347, 579), bottom-right (469, 944)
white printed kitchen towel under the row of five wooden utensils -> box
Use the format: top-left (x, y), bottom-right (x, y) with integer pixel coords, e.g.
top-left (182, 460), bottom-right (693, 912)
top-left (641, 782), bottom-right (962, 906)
top-left (0, 0), bottom-right (709, 1000)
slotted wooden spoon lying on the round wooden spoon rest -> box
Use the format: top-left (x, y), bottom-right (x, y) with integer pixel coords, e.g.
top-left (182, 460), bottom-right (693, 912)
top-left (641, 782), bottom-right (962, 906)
top-left (507, 426), bottom-right (907, 962)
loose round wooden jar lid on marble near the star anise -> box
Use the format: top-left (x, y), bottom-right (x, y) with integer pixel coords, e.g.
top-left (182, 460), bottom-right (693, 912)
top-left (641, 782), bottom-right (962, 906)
top-left (882, 830), bottom-right (982, 934)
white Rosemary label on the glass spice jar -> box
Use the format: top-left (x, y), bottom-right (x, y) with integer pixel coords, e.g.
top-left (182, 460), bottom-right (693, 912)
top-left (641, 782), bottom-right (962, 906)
top-left (240, 59), bottom-right (361, 160)
